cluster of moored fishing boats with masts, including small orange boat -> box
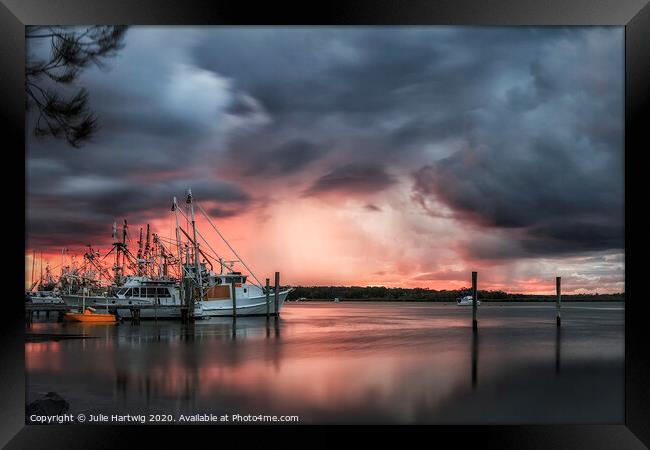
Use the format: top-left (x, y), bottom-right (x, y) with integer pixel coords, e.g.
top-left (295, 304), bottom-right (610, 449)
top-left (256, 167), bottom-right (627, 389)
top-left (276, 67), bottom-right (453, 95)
top-left (25, 189), bottom-right (292, 322)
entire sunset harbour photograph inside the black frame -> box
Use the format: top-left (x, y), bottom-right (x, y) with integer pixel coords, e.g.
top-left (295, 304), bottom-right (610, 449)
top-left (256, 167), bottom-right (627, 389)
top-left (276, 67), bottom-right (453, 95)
top-left (22, 25), bottom-right (626, 428)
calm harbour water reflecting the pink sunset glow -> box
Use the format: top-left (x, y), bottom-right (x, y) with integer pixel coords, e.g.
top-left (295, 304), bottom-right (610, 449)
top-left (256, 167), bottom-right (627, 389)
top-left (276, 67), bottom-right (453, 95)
top-left (25, 302), bottom-right (624, 424)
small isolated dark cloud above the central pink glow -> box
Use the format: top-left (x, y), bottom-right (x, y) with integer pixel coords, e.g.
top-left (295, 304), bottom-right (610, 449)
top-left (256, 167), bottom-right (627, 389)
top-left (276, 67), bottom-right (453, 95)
top-left (304, 164), bottom-right (395, 195)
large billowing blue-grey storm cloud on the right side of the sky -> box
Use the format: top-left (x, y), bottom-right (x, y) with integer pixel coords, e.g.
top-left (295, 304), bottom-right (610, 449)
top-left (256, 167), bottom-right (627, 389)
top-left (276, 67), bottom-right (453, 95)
top-left (413, 26), bottom-right (624, 258)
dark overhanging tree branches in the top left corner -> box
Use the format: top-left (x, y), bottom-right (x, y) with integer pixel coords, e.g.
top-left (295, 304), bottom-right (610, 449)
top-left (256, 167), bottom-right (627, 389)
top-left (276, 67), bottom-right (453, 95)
top-left (25, 26), bottom-right (126, 148)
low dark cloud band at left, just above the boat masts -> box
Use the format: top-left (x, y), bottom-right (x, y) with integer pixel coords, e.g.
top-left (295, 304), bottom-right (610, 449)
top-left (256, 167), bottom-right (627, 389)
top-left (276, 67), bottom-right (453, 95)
top-left (27, 171), bottom-right (252, 247)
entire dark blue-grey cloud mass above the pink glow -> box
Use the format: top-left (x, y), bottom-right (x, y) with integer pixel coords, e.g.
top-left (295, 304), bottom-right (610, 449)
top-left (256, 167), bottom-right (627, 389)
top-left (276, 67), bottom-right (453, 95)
top-left (27, 27), bottom-right (623, 258)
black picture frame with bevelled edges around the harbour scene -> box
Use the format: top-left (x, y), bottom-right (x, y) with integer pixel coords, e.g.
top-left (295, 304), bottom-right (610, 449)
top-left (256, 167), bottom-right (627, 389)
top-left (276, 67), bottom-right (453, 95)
top-left (0, 0), bottom-right (650, 449)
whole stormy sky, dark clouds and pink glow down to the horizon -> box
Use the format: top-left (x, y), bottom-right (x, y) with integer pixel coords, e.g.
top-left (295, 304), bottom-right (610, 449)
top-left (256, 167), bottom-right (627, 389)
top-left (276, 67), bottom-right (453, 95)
top-left (26, 27), bottom-right (624, 292)
